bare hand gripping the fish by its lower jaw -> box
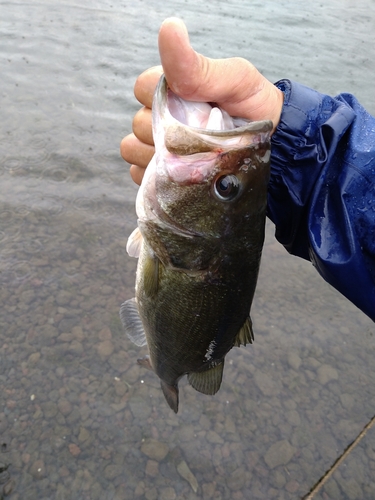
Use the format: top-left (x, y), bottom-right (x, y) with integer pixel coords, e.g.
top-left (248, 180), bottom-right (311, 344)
top-left (120, 18), bottom-right (284, 184)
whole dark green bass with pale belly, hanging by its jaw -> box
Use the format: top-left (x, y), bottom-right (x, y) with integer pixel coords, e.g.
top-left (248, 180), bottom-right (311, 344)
top-left (120, 76), bottom-right (272, 413)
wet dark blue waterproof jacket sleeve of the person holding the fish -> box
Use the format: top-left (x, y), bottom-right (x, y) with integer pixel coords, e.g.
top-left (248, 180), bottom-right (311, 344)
top-left (268, 80), bottom-right (375, 321)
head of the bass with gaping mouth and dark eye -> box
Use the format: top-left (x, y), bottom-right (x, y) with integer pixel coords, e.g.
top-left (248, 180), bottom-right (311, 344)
top-left (137, 77), bottom-right (272, 243)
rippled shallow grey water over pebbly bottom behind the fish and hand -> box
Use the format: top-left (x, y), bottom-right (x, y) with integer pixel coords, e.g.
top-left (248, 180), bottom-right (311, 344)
top-left (0, 0), bottom-right (375, 500)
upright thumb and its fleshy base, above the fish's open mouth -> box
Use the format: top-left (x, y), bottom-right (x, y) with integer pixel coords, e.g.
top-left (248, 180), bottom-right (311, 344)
top-left (159, 17), bottom-right (282, 128)
